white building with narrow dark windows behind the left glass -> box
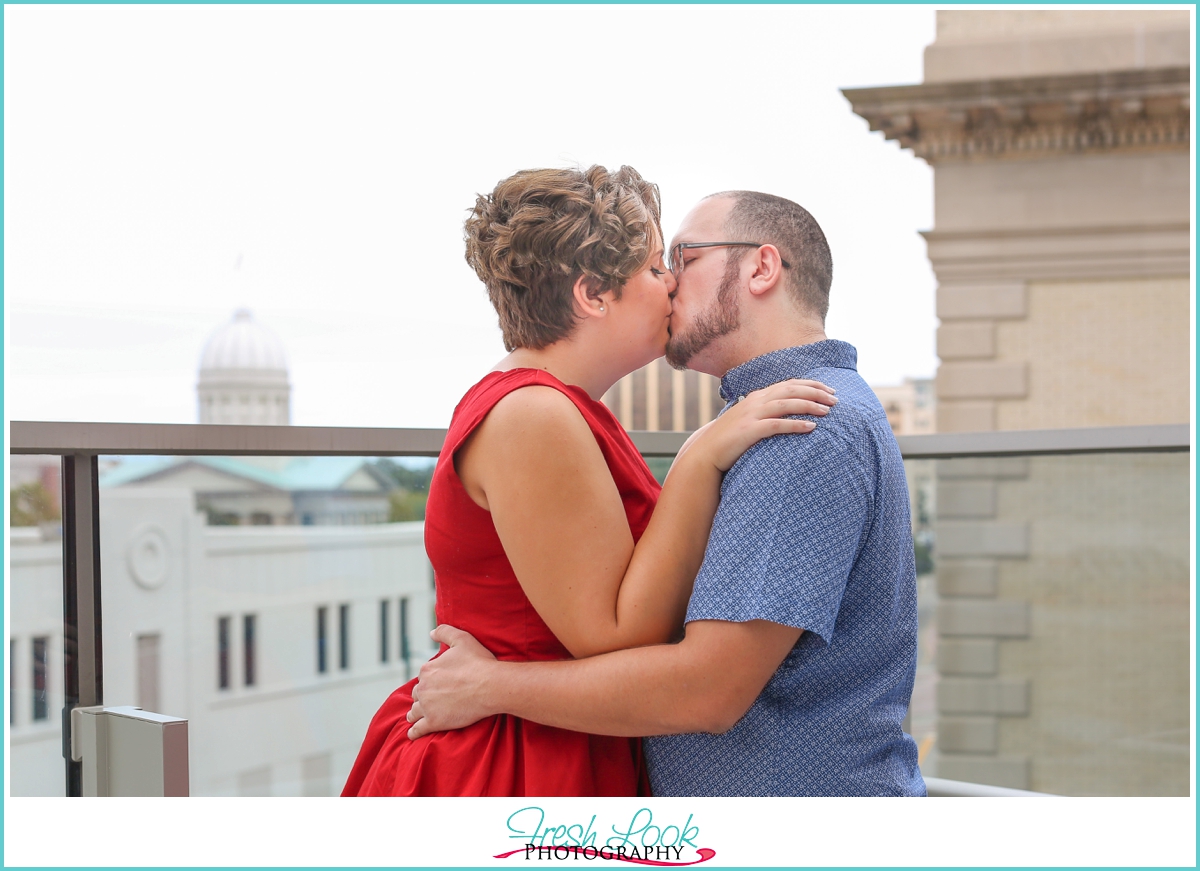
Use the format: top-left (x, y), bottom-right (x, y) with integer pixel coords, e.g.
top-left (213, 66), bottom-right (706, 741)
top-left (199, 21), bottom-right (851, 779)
top-left (10, 488), bottom-right (433, 795)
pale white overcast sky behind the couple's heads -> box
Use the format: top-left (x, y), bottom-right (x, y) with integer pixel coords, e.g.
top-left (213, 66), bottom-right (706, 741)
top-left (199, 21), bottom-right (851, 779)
top-left (4, 6), bottom-right (936, 426)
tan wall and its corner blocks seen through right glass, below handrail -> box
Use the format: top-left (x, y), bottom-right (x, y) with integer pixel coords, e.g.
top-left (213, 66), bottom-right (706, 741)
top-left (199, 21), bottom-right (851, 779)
top-left (932, 453), bottom-right (1192, 795)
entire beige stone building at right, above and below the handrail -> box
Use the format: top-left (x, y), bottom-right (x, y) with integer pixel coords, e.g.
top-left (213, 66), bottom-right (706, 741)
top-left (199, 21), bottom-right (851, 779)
top-left (845, 10), bottom-right (1192, 795)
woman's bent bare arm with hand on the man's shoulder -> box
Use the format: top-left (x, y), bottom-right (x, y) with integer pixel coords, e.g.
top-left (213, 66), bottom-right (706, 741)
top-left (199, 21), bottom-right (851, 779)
top-left (455, 383), bottom-right (826, 657)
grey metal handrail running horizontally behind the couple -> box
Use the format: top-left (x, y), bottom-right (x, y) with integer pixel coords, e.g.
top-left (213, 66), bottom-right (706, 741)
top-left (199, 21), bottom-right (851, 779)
top-left (8, 420), bottom-right (1190, 459)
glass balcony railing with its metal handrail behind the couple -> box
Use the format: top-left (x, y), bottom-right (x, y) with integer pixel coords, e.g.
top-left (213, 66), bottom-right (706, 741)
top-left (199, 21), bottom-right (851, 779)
top-left (8, 422), bottom-right (1190, 795)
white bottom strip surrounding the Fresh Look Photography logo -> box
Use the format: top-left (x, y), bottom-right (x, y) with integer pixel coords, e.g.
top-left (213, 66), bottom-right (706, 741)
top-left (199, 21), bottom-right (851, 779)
top-left (4, 798), bottom-right (1195, 871)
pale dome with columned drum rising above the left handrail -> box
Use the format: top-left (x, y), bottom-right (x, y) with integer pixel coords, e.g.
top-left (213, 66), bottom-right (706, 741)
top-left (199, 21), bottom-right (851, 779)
top-left (196, 308), bottom-right (292, 426)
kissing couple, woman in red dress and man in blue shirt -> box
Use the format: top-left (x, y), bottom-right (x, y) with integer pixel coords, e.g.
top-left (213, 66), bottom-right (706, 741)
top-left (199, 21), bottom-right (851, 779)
top-left (342, 167), bottom-right (925, 795)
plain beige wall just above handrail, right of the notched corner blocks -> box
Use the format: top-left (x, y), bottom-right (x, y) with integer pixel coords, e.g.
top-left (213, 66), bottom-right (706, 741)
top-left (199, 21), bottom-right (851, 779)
top-left (996, 277), bottom-right (1190, 430)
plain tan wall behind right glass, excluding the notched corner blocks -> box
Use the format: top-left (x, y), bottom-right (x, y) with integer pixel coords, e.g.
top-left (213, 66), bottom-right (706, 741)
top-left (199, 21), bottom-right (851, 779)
top-left (997, 453), bottom-right (1190, 795)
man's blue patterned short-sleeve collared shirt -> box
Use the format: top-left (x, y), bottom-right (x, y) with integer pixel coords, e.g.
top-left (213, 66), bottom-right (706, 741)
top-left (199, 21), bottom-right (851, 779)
top-left (644, 341), bottom-right (925, 795)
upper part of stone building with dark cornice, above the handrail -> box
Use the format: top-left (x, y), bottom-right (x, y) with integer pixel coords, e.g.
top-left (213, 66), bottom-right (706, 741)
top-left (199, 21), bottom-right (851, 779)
top-left (845, 11), bottom-right (1190, 432)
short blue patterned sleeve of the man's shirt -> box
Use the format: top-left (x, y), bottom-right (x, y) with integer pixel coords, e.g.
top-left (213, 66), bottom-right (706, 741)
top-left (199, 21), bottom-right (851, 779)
top-left (686, 426), bottom-right (874, 644)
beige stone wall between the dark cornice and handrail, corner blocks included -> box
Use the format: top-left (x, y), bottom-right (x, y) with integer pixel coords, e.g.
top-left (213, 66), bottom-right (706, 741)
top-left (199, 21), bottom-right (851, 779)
top-left (926, 96), bottom-right (1192, 432)
